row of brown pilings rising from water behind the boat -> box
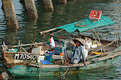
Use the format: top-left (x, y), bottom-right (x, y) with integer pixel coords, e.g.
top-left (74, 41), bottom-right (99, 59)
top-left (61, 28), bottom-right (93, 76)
top-left (1, 0), bottom-right (76, 30)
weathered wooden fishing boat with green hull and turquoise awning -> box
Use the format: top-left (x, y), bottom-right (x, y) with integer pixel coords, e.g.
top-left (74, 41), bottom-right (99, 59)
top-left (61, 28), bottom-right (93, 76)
top-left (2, 16), bottom-right (121, 77)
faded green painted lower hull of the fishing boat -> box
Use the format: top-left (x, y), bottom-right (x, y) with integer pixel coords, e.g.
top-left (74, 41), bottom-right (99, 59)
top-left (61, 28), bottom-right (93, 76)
top-left (8, 56), bottom-right (118, 77)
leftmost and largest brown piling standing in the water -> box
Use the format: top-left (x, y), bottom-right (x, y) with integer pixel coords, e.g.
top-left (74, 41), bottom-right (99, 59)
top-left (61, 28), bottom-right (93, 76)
top-left (2, 0), bottom-right (18, 30)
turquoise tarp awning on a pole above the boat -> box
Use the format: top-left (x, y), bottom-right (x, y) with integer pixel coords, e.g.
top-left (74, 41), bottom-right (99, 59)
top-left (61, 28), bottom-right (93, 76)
top-left (40, 16), bottom-right (114, 33)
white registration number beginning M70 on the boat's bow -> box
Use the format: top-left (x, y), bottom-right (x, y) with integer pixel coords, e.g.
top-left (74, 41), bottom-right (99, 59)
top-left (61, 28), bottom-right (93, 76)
top-left (14, 54), bottom-right (36, 60)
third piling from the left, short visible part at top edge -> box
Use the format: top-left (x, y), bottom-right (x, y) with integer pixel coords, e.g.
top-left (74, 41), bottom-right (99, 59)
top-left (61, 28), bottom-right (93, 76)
top-left (43, 0), bottom-right (54, 12)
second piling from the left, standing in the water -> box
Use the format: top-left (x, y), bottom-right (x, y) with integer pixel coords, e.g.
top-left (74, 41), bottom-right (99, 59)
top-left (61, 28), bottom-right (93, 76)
top-left (24, 0), bottom-right (38, 18)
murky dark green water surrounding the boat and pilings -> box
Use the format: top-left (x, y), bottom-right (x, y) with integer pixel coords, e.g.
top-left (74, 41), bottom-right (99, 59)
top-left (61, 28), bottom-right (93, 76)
top-left (0, 0), bottom-right (121, 80)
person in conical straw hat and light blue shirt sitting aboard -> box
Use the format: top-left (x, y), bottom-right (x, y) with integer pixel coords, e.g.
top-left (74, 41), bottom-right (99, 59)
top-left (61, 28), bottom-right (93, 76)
top-left (71, 38), bottom-right (87, 65)
